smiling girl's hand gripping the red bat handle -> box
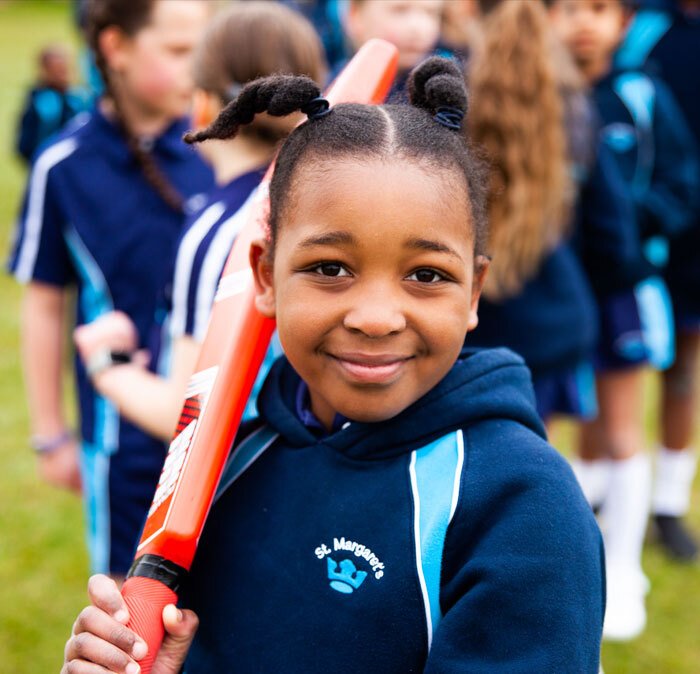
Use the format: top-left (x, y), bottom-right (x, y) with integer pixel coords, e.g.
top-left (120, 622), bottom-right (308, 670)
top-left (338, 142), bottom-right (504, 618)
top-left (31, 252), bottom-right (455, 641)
top-left (61, 575), bottom-right (198, 674)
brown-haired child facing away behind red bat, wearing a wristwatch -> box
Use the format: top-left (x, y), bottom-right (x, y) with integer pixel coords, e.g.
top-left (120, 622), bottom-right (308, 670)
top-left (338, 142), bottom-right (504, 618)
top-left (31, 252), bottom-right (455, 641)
top-left (69, 2), bottom-right (324, 440)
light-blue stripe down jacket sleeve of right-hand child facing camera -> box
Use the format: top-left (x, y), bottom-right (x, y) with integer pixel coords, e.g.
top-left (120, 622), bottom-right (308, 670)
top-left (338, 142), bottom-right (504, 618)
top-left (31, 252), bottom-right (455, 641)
top-left (613, 72), bottom-right (656, 194)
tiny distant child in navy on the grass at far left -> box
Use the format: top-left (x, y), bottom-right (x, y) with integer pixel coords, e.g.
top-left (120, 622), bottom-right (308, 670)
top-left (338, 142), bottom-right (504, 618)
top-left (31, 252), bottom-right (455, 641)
top-left (17, 45), bottom-right (86, 163)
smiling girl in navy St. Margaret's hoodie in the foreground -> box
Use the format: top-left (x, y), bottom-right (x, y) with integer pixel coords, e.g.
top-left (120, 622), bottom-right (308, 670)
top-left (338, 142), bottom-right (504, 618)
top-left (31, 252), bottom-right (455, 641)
top-left (63, 58), bottom-right (604, 674)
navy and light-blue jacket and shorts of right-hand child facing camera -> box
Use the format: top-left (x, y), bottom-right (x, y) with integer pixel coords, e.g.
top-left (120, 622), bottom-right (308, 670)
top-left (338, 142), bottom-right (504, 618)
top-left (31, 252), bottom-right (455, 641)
top-left (593, 70), bottom-right (699, 370)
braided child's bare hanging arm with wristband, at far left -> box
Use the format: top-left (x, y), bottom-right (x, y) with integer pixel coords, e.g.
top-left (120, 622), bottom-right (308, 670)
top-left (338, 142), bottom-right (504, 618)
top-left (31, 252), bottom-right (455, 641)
top-left (21, 282), bottom-right (80, 491)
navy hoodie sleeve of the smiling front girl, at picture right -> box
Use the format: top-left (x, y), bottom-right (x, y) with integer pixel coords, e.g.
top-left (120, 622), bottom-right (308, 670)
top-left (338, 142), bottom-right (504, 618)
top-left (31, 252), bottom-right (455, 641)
top-left (425, 424), bottom-right (605, 674)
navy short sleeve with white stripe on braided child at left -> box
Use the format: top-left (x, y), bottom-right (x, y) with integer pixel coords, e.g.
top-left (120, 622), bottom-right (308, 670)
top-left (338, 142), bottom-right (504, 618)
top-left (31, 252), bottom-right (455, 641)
top-left (9, 138), bottom-right (77, 286)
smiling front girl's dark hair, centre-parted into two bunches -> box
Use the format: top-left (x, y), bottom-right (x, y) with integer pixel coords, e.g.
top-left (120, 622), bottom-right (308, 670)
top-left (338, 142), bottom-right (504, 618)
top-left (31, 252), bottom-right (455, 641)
top-left (185, 57), bottom-right (486, 255)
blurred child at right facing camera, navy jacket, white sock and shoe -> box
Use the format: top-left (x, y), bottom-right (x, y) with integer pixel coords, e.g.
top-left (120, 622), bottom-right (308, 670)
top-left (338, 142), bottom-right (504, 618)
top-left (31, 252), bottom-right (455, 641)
top-left (552, 0), bottom-right (697, 640)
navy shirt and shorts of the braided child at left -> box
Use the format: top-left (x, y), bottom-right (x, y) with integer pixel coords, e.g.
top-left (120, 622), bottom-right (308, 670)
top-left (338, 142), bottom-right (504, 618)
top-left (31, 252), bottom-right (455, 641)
top-left (9, 109), bottom-right (212, 574)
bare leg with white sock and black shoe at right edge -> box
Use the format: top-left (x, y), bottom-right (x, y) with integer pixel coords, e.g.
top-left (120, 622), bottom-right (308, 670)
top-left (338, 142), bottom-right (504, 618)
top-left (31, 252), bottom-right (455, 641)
top-left (652, 330), bottom-right (700, 560)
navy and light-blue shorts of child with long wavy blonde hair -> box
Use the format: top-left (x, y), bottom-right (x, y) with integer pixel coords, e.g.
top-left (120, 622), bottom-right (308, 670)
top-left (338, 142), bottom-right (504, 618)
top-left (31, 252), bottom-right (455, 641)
top-left (532, 361), bottom-right (598, 421)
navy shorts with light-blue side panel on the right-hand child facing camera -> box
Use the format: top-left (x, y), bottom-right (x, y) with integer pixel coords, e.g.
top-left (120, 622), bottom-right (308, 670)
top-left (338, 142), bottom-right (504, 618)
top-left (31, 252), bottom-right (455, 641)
top-left (595, 276), bottom-right (675, 372)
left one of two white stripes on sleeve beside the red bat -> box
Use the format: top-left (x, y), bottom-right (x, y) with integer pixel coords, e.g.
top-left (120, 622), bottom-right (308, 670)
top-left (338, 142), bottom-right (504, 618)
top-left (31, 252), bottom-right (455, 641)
top-left (170, 201), bottom-right (226, 337)
